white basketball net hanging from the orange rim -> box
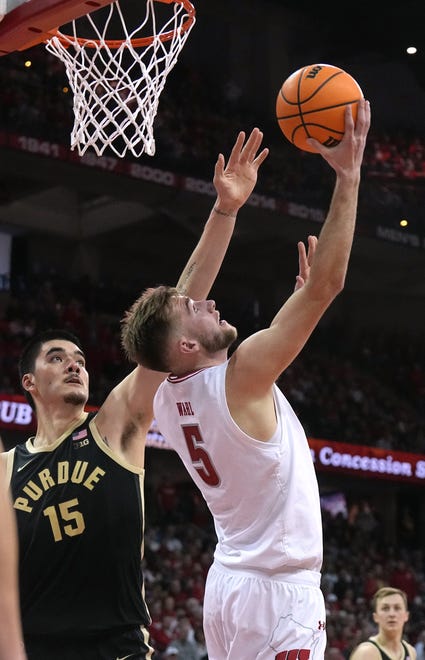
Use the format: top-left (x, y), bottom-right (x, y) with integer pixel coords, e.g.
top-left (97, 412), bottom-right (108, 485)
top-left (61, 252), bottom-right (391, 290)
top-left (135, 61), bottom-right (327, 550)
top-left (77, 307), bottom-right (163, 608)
top-left (46, 0), bottom-right (195, 158)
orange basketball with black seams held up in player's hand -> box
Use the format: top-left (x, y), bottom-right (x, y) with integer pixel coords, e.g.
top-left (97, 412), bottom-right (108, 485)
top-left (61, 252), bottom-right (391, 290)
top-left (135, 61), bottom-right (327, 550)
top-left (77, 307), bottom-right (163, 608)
top-left (276, 64), bottom-right (363, 153)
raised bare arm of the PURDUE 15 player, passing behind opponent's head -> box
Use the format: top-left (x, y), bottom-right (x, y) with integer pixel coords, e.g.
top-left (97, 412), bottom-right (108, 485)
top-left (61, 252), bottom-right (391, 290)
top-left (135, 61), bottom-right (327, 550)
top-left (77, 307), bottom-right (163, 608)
top-left (96, 128), bottom-right (268, 458)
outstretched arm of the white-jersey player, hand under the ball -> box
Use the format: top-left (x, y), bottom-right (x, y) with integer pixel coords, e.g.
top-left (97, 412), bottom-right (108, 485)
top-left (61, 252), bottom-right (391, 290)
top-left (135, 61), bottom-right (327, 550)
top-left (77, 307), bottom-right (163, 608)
top-left (229, 100), bottom-right (370, 399)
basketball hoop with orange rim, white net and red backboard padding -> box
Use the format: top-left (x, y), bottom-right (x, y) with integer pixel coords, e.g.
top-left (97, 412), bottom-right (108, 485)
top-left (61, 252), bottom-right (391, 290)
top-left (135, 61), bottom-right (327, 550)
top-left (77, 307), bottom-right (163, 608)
top-left (0, 0), bottom-right (195, 158)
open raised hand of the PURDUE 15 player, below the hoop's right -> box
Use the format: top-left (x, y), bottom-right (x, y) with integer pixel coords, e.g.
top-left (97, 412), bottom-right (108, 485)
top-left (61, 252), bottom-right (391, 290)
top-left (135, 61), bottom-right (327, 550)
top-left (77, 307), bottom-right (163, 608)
top-left (213, 128), bottom-right (269, 213)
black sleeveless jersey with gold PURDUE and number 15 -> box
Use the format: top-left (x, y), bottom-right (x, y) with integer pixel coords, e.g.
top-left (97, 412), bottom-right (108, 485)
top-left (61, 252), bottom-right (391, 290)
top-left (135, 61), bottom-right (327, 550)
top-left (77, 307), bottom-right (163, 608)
top-left (9, 413), bottom-right (150, 635)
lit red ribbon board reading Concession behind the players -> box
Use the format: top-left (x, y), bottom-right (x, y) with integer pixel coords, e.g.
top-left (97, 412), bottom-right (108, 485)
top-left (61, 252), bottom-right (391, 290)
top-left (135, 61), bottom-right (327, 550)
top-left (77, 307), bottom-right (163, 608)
top-left (0, 394), bottom-right (425, 485)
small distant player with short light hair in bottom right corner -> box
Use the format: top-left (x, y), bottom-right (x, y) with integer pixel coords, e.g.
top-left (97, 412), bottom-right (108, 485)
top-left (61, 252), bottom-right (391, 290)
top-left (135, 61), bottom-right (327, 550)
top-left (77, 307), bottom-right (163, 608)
top-left (350, 587), bottom-right (416, 660)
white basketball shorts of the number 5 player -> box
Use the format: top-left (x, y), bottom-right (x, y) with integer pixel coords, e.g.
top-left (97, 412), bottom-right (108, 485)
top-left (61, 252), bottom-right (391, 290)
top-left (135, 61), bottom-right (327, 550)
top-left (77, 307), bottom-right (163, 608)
top-left (204, 562), bottom-right (326, 660)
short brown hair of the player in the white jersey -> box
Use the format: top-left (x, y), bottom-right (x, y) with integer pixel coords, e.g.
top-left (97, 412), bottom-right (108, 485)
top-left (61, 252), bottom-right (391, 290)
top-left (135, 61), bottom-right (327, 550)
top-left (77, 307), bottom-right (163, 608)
top-left (121, 285), bottom-right (178, 372)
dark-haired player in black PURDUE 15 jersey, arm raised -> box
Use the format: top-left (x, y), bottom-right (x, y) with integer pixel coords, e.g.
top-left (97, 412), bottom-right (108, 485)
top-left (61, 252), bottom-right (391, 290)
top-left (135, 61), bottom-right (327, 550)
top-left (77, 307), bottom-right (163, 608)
top-left (2, 128), bottom-right (268, 660)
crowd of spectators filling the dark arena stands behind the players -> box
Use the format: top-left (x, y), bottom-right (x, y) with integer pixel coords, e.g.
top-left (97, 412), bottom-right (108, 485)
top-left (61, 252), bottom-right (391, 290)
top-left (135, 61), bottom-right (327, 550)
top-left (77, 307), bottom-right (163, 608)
top-left (0, 42), bottom-right (425, 660)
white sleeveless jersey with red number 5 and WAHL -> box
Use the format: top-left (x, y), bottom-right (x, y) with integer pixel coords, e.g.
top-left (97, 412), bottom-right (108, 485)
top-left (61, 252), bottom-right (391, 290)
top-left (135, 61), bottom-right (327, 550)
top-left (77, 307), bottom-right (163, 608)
top-left (154, 362), bottom-right (323, 573)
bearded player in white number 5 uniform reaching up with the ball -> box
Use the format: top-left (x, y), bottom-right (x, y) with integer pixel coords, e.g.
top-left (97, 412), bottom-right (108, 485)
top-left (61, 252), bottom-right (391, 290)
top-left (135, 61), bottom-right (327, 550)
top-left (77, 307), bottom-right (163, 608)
top-left (122, 100), bottom-right (370, 660)
